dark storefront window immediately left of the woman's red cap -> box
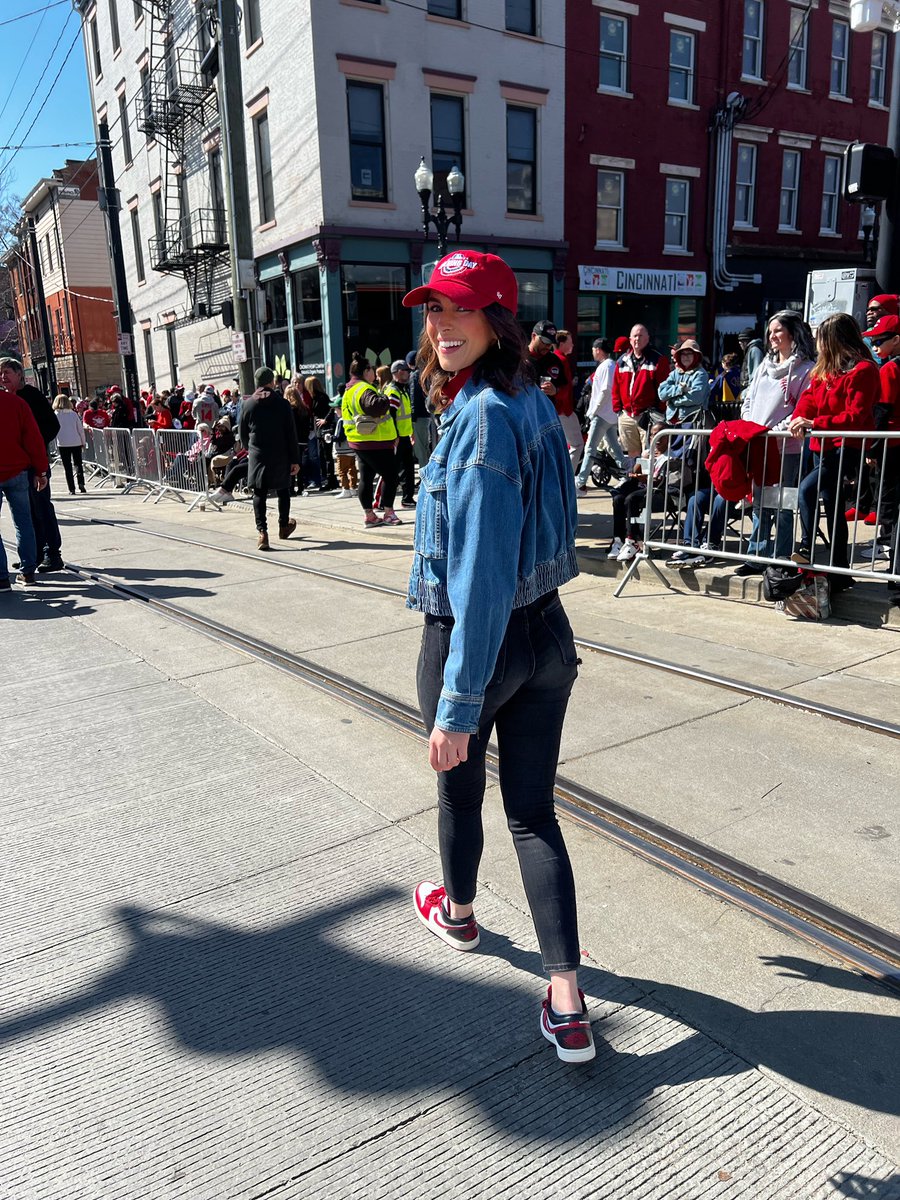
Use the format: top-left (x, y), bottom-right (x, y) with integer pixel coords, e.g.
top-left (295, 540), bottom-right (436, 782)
top-left (341, 263), bottom-right (413, 365)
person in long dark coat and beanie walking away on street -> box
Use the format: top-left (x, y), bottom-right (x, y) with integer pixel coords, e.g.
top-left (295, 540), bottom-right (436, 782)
top-left (240, 367), bottom-right (300, 550)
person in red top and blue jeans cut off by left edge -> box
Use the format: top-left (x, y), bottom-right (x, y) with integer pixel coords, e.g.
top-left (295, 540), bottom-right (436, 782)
top-left (0, 391), bottom-right (49, 592)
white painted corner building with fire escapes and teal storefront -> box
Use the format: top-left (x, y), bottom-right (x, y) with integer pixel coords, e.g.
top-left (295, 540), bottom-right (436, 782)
top-left (75, 0), bottom-right (565, 386)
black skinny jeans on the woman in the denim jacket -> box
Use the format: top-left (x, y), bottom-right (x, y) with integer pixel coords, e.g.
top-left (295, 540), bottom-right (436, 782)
top-left (416, 592), bottom-right (580, 973)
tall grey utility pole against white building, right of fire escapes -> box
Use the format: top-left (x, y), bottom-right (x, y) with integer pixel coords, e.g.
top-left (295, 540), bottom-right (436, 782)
top-left (216, 0), bottom-right (254, 396)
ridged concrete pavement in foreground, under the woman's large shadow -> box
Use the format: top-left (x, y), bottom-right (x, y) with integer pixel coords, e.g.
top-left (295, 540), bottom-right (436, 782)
top-left (0, 581), bottom-right (900, 1200)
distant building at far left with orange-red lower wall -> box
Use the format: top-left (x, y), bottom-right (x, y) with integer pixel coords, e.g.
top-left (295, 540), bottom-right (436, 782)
top-left (4, 158), bottom-right (121, 395)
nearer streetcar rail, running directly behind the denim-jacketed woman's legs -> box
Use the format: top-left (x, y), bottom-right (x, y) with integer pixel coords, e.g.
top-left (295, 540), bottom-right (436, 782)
top-left (60, 564), bottom-right (900, 991)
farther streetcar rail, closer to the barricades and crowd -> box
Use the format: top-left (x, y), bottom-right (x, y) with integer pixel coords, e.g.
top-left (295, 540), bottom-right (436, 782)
top-left (81, 517), bottom-right (900, 738)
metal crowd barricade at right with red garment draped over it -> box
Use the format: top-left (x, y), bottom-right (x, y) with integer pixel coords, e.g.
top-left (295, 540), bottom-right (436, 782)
top-left (613, 427), bottom-right (900, 596)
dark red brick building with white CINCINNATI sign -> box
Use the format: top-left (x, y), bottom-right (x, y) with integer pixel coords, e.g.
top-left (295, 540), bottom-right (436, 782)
top-left (565, 0), bottom-right (890, 360)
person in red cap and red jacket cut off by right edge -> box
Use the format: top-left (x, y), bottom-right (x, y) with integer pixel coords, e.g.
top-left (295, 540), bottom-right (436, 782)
top-left (862, 316), bottom-right (900, 590)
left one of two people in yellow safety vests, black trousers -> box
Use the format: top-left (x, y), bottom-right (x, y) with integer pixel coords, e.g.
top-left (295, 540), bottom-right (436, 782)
top-left (341, 354), bottom-right (403, 529)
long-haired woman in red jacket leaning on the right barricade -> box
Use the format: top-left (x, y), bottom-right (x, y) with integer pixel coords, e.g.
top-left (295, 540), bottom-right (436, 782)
top-left (790, 312), bottom-right (881, 590)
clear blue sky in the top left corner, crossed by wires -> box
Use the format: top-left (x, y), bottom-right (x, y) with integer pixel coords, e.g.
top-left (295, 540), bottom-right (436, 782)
top-left (0, 0), bottom-right (94, 197)
